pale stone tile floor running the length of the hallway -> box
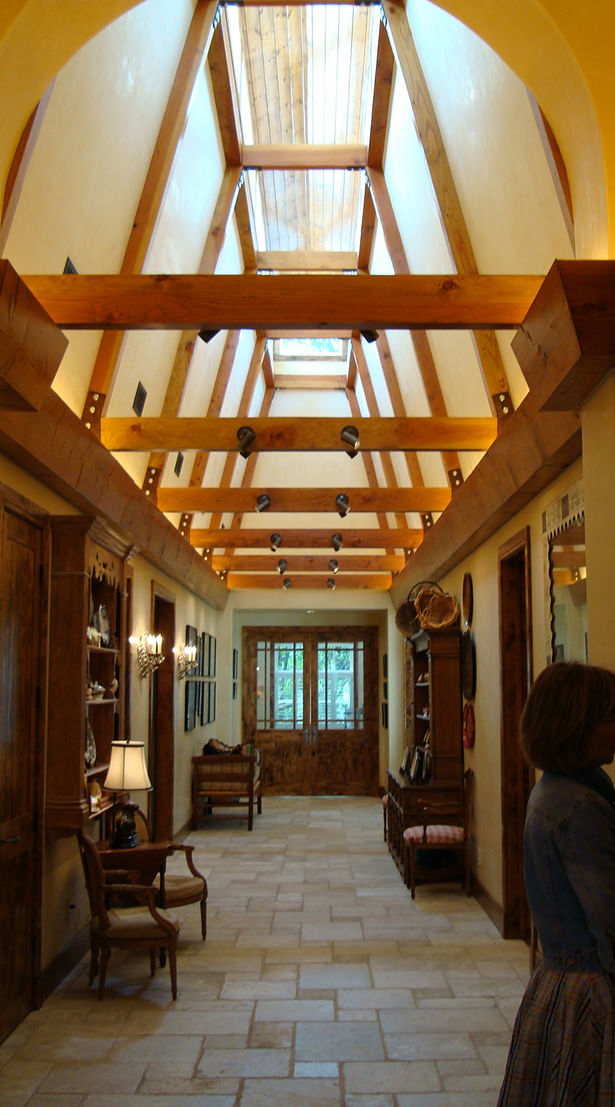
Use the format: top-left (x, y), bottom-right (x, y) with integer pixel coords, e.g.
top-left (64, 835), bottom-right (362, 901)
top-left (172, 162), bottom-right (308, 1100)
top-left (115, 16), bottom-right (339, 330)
top-left (0, 797), bottom-right (528, 1107)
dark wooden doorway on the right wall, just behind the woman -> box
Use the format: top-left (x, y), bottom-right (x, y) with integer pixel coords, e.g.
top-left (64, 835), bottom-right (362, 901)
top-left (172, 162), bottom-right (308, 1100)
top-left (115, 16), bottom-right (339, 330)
top-left (498, 527), bottom-right (533, 939)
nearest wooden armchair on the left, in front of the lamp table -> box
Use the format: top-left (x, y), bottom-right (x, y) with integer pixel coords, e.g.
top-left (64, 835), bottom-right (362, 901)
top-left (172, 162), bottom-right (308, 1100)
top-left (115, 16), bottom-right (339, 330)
top-left (77, 830), bottom-right (179, 1000)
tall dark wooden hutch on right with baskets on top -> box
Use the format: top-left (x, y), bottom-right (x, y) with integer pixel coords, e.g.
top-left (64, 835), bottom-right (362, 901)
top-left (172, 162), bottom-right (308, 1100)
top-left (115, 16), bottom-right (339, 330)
top-left (387, 628), bottom-right (463, 868)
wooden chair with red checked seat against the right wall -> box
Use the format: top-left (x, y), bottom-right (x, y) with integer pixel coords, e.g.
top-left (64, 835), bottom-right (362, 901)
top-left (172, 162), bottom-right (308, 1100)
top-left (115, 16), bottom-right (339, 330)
top-left (403, 768), bottom-right (473, 899)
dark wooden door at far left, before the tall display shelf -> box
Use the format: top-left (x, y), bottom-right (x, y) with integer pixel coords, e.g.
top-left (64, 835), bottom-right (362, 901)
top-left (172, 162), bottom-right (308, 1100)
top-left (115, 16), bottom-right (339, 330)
top-left (0, 489), bottom-right (46, 1041)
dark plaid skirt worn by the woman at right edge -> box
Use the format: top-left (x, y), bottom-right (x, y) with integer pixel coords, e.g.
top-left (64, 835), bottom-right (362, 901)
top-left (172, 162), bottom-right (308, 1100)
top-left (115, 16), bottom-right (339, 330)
top-left (498, 965), bottom-right (615, 1107)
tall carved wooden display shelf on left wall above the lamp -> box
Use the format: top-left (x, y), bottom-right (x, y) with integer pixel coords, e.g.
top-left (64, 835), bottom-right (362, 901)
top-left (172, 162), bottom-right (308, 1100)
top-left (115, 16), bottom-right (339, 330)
top-left (45, 516), bottom-right (127, 832)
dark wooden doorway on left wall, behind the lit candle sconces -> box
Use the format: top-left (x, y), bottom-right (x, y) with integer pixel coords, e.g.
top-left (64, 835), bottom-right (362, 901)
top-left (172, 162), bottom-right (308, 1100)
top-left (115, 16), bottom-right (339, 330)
top-left (147, 580), bottom-right (176, 838)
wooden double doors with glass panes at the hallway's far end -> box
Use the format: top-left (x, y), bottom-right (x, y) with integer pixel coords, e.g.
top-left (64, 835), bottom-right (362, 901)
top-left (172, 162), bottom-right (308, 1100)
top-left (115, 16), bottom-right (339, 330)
top-left (242, 627), bottom-right (378, 796)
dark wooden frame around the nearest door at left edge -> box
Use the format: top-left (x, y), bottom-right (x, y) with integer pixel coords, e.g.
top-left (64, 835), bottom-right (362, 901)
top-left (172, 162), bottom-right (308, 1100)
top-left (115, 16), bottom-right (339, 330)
top-left (0, 483), bottom-right (51, 1027)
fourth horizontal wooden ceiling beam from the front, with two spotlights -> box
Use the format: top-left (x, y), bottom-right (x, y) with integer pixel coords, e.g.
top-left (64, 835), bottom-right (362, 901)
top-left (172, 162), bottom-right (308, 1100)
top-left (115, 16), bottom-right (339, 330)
top-left (190, 524), bottom-right (423, 546)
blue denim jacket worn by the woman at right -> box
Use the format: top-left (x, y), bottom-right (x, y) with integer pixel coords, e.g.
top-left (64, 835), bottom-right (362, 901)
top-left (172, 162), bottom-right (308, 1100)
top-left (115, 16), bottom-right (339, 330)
top-left (523, 769), bottom-right (615, 974)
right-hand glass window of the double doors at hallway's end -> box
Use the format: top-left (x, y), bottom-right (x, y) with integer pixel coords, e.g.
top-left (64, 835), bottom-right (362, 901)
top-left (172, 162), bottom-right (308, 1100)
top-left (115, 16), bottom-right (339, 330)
top-left (317, 641), bottom-right (365, 731)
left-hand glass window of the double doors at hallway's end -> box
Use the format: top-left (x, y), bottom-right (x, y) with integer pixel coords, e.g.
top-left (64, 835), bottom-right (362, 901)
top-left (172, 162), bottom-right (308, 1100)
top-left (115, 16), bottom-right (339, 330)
top-left (257, 641), bottom-right (303, 731)
